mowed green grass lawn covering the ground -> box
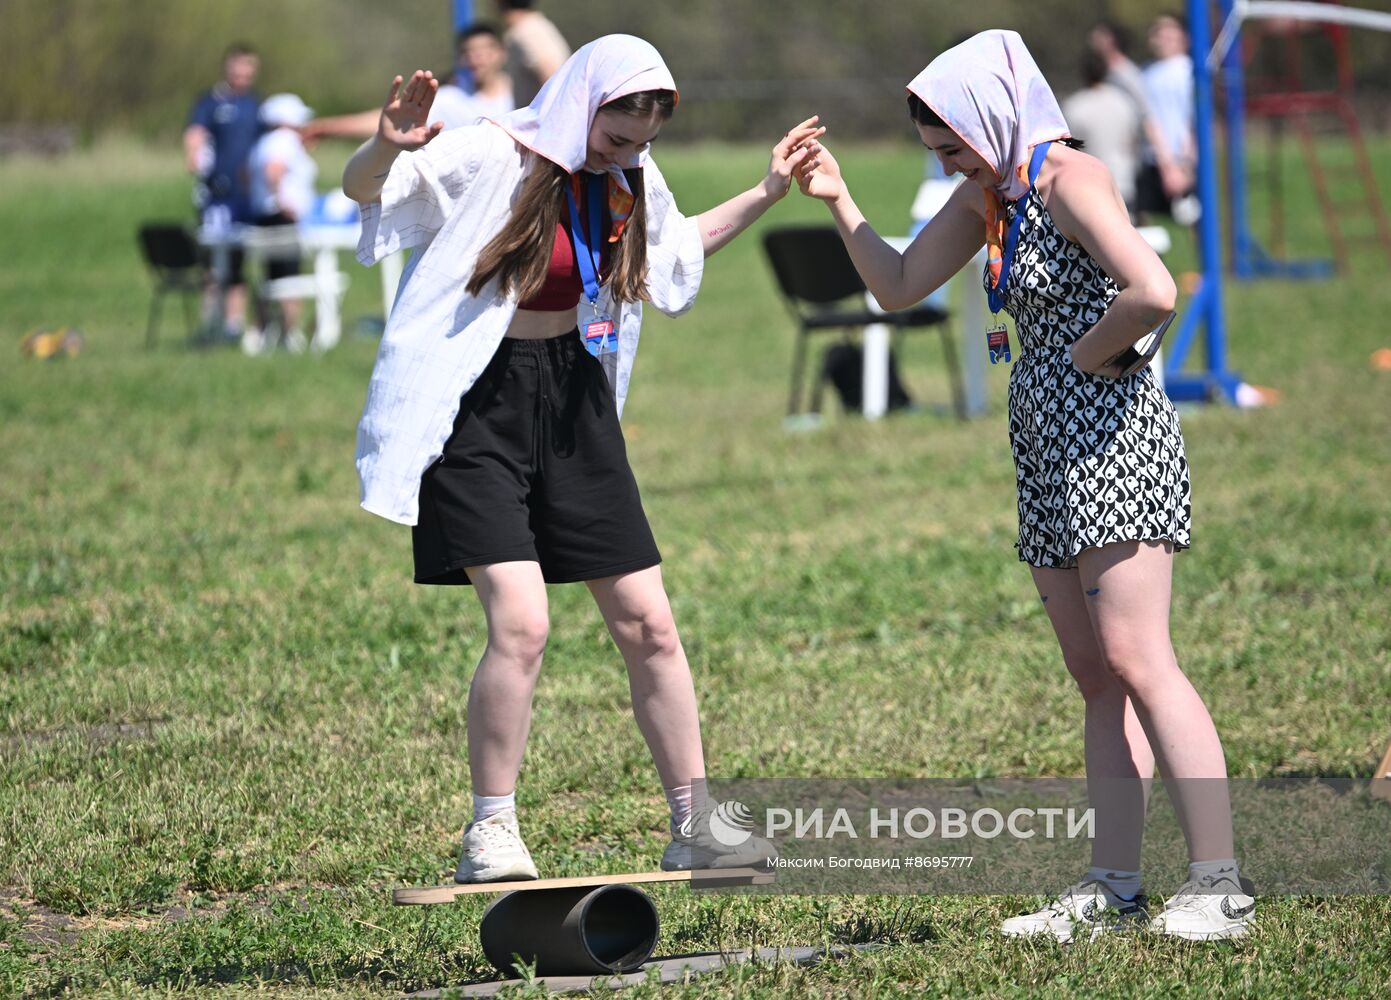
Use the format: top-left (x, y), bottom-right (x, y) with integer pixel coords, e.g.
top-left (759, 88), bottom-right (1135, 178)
top-left (0, 134), bottom-right (1391, 997)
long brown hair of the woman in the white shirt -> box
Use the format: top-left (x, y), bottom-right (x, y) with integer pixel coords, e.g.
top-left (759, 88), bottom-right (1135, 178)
top-left (467, 90), bottom-right (676, 302)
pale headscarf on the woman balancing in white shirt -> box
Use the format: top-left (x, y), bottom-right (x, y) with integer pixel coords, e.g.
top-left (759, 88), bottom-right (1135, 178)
top-left (494, 35), bottom-right (676, 191)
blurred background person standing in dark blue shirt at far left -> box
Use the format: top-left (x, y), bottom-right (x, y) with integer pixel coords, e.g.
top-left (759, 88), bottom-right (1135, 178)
top-left (184, 42), bottom-right (262, 342)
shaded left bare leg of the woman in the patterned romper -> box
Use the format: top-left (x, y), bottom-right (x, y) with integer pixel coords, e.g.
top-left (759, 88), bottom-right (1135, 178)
top-left (1032, 566), bottom-right (1155, 872)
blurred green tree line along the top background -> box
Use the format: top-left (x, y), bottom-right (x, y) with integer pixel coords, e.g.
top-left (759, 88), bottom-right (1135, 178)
top-left (8, 0), bottom-right (1391, 140)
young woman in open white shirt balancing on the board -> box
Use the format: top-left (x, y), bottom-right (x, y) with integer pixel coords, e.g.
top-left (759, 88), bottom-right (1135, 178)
top-left (344, 35), bottom-right (821, 882)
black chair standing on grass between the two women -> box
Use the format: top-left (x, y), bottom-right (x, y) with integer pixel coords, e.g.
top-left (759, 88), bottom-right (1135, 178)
top-left (764, 225), bottom-right (965, 417)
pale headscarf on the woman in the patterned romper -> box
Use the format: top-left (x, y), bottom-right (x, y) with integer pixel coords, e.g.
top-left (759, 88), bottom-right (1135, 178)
top-left (908, 29), bottom-right (1072, 202)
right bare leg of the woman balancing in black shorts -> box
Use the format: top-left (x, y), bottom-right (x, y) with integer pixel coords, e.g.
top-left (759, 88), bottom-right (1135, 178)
top-left (588, 566), bottom-right (705, 789)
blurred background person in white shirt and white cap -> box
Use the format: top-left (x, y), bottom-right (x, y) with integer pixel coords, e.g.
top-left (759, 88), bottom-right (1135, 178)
top-left (242, 93), bottom-right (319, 355)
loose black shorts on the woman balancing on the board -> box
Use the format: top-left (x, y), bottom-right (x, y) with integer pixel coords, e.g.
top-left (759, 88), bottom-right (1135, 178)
top-left (412, 330), bottom-right (662, 584)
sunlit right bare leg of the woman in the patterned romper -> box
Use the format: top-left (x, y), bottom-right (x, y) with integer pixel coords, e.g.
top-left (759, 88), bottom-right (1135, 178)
top-left (1077, 541), bottom-right (1234, 861)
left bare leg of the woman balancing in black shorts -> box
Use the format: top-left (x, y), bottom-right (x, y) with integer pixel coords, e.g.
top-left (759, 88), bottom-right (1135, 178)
top-left (467, 562), bottom-right (549, 796)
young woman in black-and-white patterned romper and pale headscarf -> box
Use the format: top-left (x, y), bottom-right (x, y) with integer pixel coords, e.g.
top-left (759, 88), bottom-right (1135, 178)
top-left (798, 31), bottom-right (1255, 940)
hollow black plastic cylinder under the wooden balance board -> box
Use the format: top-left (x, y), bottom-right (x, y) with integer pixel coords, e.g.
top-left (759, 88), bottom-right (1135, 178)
top-left (479, 885), bottom-right (661, 976)
